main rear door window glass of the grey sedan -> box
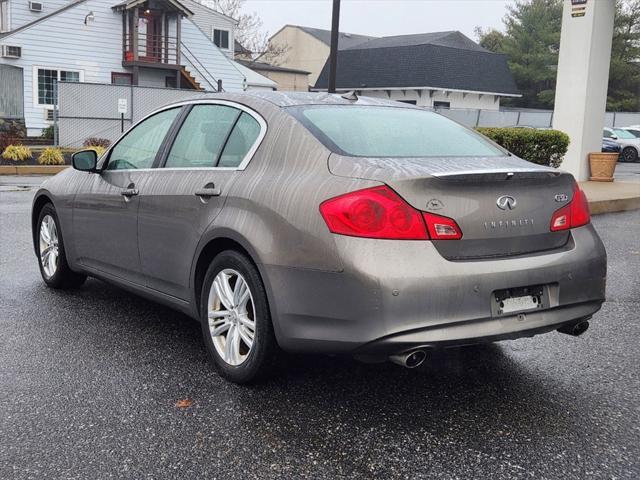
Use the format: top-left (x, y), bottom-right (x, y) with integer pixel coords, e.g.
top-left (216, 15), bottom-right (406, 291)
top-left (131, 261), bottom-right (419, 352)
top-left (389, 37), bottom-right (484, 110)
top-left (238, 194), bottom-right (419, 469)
top-left (165, 105), bottom-right (242, 168)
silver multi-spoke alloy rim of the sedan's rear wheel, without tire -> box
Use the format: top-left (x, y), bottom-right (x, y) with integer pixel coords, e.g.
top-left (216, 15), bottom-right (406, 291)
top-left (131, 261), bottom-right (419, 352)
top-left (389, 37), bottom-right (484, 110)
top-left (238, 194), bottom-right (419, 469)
top-left (207, 268), bottom-right (256, 366)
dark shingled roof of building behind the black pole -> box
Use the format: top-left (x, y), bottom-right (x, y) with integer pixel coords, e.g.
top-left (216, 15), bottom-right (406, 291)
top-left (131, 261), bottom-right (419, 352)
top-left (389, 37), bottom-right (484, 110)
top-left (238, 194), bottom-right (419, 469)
top-left (314, 32), bottom-right (519, 96)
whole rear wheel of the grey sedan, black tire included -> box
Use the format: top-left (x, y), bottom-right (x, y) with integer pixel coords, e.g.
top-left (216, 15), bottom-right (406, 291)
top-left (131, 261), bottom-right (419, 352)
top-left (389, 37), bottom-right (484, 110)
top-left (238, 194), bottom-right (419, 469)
top-left (200, 250), bottom-right (278, 383)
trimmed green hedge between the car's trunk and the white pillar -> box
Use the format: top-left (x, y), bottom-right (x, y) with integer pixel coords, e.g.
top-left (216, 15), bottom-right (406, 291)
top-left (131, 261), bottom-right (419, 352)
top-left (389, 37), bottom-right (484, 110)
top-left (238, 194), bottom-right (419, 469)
top-left (477, 128), bottom-right (569, 168)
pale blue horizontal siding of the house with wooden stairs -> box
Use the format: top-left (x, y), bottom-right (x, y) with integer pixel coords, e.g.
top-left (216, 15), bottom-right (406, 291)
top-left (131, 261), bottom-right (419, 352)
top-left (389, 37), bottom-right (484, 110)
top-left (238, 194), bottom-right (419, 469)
top-left (0, 0), bottom-right (244, 134)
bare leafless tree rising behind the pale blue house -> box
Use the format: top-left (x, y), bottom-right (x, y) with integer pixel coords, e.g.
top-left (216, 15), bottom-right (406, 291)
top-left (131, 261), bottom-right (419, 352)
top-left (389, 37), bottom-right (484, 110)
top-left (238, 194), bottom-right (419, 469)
top-left (200, 0), bottom-right (288, 63)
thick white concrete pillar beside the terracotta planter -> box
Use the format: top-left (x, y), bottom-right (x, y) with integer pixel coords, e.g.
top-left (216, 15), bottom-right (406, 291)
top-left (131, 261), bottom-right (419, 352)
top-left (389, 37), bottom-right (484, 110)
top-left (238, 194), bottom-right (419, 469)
top-left (553, 0), bottom-right (615, 181)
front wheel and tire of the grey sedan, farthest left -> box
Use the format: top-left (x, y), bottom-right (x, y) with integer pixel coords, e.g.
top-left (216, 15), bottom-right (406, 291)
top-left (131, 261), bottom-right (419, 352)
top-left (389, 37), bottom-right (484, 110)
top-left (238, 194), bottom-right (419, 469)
top-left (36, 203), bottom-right (87, 289)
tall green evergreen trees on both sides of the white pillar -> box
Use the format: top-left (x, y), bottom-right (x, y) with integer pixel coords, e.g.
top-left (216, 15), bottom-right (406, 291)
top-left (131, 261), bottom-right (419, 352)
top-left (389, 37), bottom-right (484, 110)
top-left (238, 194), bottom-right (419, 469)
top-left (476, 0), bottom-right (640, 111)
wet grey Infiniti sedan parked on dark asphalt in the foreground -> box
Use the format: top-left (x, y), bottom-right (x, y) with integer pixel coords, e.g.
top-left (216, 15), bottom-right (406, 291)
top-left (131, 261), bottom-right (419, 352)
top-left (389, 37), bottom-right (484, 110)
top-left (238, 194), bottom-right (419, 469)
top-left (32, 92), bottom-right (606, 382)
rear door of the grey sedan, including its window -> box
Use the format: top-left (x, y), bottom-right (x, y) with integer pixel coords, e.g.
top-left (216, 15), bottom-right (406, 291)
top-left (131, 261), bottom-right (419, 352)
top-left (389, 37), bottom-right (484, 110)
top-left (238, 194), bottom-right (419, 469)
top-left (138, 101), bottom-right (266, 300)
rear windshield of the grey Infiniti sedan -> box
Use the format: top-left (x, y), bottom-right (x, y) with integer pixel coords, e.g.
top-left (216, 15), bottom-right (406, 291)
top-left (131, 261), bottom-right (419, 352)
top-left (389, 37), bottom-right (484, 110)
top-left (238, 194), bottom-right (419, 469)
top-left (289, 105), bottom-right (507, 157)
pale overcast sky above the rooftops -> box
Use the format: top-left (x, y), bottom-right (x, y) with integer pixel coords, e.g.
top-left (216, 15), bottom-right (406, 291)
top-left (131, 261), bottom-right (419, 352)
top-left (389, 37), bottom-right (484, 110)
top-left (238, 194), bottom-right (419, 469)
top-left (243, 0), bottom-right (511, 40)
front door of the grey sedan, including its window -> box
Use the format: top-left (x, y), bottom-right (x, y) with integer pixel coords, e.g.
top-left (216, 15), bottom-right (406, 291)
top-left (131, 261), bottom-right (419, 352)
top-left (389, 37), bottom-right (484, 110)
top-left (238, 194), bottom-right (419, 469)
top-left (73, 108), bottom-right (180, 284)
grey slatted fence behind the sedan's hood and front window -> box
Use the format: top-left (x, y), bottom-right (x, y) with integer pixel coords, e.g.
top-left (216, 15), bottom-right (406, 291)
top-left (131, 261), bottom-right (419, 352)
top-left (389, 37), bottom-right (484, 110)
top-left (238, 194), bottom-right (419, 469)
top-left (54, 82), bottom-right (212, 147)
